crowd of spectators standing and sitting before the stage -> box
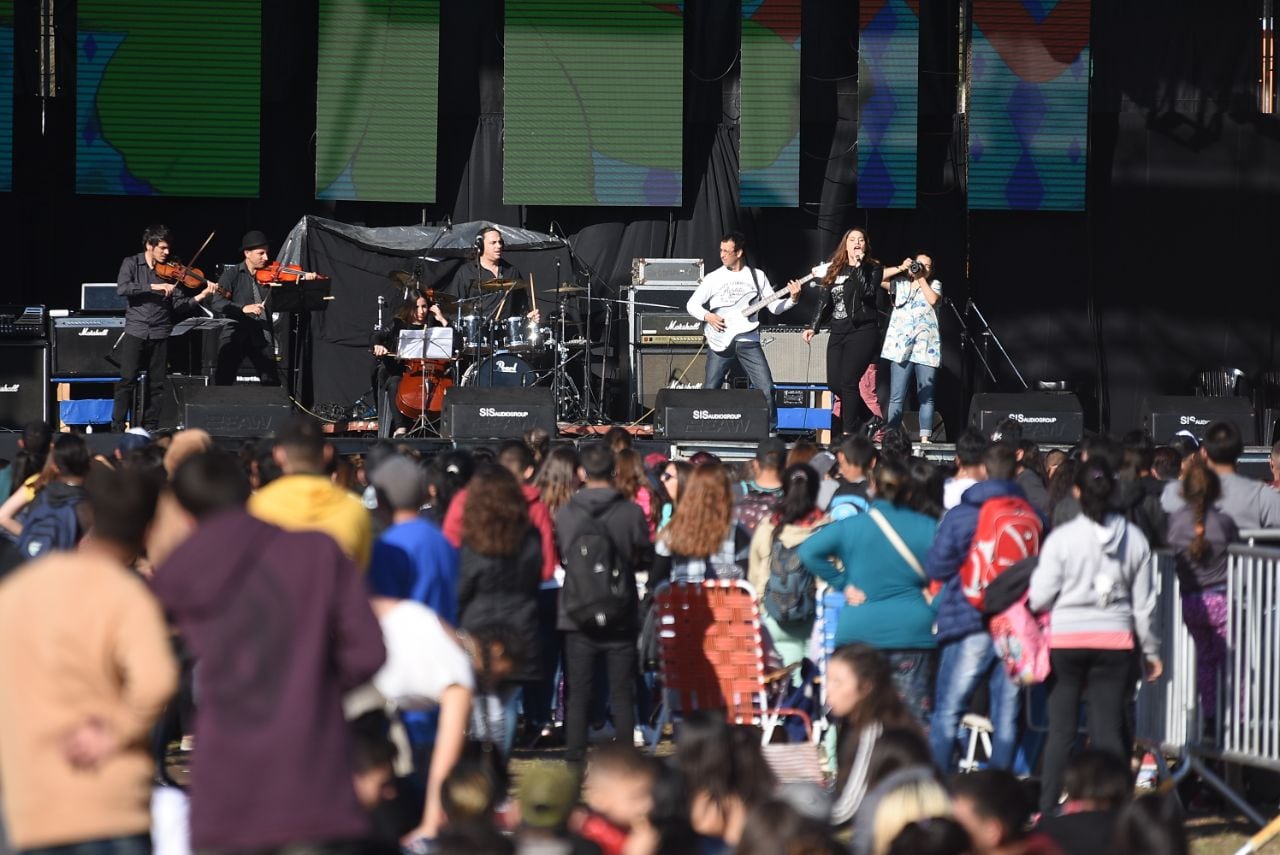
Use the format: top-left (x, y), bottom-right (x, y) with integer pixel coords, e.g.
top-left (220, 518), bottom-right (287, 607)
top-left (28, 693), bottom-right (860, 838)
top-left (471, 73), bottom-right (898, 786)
top-left (0, 420), bottom-right (1280, 855)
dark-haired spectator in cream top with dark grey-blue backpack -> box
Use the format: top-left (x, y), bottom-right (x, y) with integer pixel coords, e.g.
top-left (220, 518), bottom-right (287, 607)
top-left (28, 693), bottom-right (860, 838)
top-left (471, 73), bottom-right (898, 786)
top-left (748, 463), bottom-right (827, 666)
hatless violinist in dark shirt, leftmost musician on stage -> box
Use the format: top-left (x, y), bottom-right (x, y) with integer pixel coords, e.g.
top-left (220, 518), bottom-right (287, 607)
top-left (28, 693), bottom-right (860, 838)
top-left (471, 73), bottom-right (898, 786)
top-left (111, 225), bottom-right (215, 433)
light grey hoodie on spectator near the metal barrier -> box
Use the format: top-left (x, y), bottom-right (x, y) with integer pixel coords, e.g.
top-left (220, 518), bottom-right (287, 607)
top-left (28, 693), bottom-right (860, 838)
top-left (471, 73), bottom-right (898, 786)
top-left (1028, 513), bottom-right (1160, 659)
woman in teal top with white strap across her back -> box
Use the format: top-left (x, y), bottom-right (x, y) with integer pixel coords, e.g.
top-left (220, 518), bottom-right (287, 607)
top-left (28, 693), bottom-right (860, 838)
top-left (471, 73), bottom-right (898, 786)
top-left (799, 462), bottom-right (938, 721)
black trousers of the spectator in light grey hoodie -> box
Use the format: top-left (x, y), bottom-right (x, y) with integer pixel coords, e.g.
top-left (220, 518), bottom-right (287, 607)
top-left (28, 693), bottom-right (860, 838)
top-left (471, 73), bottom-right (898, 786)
top-left (1041, 648), bottom-right (1139, 817)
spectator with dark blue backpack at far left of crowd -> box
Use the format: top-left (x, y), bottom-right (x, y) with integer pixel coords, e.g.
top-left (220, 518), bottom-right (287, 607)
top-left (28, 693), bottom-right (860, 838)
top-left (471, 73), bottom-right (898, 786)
top-left (18, 434), bottom-right (93, 559)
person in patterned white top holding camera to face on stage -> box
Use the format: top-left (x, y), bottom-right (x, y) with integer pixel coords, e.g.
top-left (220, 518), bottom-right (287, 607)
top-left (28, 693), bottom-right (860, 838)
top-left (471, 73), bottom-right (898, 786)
top-left (881, 252), bottom-right (942, 443)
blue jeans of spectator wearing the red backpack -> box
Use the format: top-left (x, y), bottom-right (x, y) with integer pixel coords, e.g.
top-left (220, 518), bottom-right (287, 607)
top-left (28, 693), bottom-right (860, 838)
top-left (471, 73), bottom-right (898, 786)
top-left (929, 632), bottom-right (1019, 773)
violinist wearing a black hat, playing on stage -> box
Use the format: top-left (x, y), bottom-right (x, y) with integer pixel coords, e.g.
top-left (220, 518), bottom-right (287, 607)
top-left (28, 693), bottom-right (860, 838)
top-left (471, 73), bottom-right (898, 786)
top-left (209, 229), bottom-right (316, 387)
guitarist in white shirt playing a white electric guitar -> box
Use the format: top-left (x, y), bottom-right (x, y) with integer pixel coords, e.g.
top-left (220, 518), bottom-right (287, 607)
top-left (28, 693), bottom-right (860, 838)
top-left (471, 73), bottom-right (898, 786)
top-left (685, 232), bottom-right (800, 430)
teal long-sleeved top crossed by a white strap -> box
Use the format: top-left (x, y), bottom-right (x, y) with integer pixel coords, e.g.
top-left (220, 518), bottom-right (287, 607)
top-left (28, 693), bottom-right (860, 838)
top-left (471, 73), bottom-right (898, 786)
top-left (797, 499), bottom-right (938, 650)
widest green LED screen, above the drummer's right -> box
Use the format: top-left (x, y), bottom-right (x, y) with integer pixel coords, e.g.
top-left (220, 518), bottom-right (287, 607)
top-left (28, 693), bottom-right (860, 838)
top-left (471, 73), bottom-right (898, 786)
top-left (503, 0), bottom-right (685, 206)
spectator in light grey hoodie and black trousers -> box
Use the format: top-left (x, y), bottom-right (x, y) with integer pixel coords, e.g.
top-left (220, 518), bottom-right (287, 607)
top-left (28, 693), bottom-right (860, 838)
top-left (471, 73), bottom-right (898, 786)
top-left (1029, 458), bottom-right (1164, 815)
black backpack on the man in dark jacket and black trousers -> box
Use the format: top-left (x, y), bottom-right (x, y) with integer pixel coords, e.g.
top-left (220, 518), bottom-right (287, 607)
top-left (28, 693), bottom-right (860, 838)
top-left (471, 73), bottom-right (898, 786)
top-left (561, 506), bottom-right (636, 631)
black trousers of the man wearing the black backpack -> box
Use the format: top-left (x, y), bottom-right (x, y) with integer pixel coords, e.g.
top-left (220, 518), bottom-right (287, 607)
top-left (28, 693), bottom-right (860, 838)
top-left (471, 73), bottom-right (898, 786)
top-left (564, 632), bottom-right (637, 763)
